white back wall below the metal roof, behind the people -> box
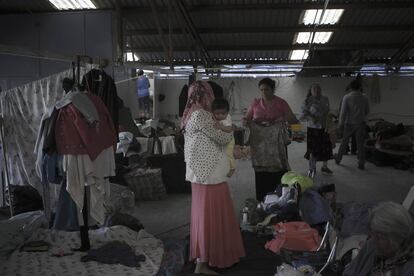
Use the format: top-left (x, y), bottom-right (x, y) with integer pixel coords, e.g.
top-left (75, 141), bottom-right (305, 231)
top-left (155, 77), bottom-right (414, 125)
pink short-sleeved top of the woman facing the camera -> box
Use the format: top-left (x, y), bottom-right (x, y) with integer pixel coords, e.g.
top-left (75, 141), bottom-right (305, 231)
top-left (247, 96), bottom-right (290, 122)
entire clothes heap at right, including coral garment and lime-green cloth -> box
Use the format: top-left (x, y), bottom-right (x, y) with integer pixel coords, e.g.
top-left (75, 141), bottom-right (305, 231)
top-left (242, 172), bottom-right (360, 275)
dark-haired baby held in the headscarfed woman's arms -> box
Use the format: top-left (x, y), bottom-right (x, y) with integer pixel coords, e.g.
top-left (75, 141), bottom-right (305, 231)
top-left (211, 98), bottom-right (236, 177)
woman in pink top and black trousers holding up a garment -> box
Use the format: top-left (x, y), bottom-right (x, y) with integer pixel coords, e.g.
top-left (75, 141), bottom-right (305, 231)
top-left (243, 78), bottom-right (298, 201)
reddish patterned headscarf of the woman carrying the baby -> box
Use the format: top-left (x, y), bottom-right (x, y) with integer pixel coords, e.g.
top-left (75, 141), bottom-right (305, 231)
top-left (181, 81), bottom-right (214, 129)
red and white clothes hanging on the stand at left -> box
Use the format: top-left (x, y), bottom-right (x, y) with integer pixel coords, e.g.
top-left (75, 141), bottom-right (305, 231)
top-left (55, 89), bottom-right (117, 225)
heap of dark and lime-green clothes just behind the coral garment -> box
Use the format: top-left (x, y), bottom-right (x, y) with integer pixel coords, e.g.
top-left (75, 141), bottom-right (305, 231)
top-left (242, 172), bottom-right (335, 245)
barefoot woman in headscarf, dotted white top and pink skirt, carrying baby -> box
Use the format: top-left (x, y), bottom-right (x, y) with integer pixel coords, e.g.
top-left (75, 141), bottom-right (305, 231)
top-left (181, 81), bottom-right (245, 275)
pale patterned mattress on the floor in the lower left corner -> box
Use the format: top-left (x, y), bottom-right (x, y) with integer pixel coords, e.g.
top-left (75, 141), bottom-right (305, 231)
top-left (0, 226), bottom-right (164, 276)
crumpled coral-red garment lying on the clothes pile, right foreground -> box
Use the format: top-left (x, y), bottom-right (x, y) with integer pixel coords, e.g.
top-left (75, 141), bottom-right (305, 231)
top-left (265, 221), bottom-right (321, 253)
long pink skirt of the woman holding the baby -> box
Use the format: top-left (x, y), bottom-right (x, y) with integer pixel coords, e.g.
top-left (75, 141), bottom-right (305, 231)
top-left (190, 182), bottom-right (245, 268)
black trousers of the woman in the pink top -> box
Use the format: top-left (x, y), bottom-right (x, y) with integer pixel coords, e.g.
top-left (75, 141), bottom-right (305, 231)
top-left (254, 171), bottom-right (286, 201)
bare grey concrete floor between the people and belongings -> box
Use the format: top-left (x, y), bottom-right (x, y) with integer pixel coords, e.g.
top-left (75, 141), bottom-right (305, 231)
top-left (134, 142), bottom-right (414, 238)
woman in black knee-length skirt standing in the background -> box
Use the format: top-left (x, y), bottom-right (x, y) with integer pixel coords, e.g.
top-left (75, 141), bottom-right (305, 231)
top-left (301, 84), bottom-right (333, 178)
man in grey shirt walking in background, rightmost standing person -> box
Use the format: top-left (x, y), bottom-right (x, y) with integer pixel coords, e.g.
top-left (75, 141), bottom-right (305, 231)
top-left (334, 79), bottom-right (369, 170)
